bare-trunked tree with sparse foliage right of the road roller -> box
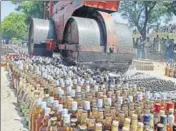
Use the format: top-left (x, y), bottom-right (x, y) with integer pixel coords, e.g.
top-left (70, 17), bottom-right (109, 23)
top-left (120, 1), bottom-right (171, 40)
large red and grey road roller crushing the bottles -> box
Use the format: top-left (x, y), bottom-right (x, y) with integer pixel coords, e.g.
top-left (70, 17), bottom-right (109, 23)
top-left (28, 0), bottom-right (136, 70)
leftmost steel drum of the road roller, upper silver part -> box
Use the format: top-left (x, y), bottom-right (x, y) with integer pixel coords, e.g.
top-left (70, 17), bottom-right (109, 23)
top-left (29, 18), bottom-right (55, 51)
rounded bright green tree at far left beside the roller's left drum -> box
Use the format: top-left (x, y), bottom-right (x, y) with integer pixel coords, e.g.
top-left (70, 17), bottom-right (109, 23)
top-left (2, 13), bottom-right (28, 40)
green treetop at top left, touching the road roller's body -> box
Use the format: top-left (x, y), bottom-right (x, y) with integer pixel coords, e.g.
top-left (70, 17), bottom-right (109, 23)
top-left (14, 1), bottom-right (44, 22)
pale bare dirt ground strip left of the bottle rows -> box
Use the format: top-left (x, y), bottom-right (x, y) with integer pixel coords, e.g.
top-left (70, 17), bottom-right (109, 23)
top-left (1, 67), bottom-right (26, 131)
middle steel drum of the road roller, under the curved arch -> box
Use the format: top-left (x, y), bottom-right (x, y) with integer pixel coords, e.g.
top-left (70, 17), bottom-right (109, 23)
top-left (64, 17), bottom-right (101, 46)
